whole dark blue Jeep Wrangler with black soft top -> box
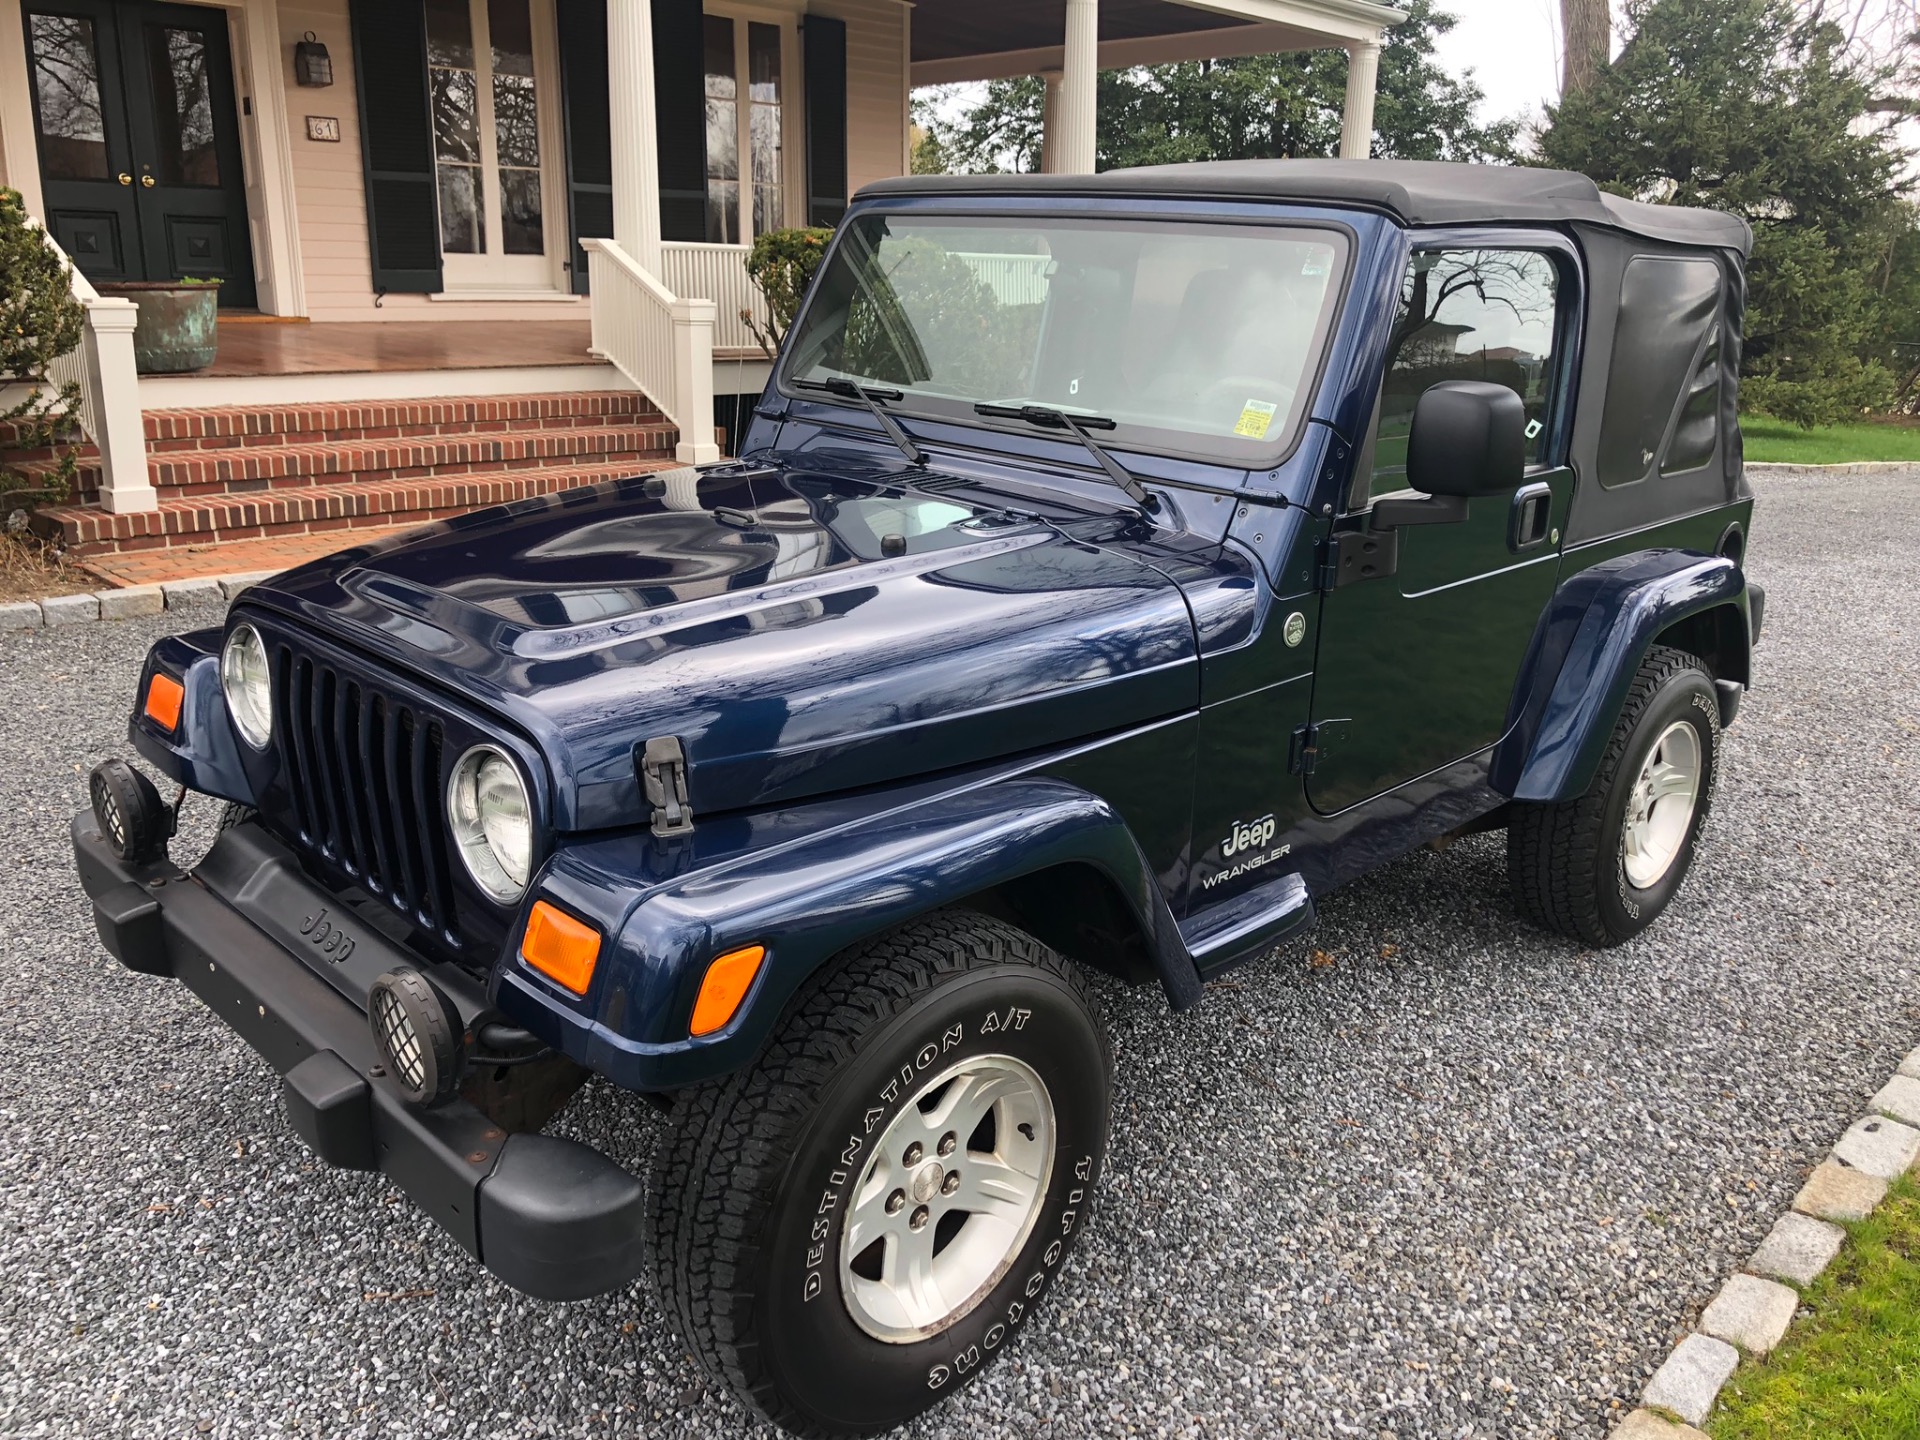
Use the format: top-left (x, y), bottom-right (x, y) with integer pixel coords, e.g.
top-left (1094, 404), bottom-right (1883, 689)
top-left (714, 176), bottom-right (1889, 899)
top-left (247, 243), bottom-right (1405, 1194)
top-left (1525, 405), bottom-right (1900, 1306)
top-left (73, 161), bottom-right (1763, 1434)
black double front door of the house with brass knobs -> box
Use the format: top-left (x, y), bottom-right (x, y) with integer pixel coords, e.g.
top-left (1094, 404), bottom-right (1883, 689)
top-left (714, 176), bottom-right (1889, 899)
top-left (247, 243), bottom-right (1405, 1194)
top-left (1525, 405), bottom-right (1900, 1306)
top-left (25, 0), bottom-right (253, 307)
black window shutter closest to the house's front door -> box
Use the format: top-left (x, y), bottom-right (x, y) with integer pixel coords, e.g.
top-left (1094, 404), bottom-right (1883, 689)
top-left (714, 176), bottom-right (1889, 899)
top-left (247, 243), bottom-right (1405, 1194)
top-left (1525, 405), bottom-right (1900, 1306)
top-left (351, 0), bottom-right (442, 294)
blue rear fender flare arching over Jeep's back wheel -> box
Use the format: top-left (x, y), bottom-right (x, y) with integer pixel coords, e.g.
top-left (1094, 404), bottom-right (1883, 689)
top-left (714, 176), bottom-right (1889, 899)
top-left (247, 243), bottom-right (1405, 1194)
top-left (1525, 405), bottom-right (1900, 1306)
top-left (1488, 549), bottom-right (1751, 803)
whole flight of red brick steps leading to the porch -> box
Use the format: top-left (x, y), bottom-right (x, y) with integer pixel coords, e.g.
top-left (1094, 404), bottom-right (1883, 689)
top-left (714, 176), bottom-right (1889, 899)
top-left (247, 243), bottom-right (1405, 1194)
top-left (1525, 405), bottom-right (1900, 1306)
top-left (23, 392), bottom-right (678, 557)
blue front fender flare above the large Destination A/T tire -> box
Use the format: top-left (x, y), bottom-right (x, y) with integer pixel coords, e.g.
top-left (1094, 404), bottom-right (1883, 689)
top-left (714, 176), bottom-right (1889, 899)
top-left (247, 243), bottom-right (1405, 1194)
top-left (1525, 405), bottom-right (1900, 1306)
top-left (497, 780), bottom-right (1202, 1091)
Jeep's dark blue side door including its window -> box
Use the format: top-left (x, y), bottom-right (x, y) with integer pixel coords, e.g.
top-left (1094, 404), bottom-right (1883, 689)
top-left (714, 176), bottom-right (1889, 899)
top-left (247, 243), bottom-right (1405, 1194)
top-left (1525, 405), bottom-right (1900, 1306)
top-left (1296, 240), bottom-right (1580, 814)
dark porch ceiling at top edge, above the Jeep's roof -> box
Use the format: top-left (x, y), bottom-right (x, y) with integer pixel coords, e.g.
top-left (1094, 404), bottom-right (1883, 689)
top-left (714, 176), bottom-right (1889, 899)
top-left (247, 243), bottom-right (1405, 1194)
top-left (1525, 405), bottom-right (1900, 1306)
top-left (912, 0), bottom-right (1405, 84)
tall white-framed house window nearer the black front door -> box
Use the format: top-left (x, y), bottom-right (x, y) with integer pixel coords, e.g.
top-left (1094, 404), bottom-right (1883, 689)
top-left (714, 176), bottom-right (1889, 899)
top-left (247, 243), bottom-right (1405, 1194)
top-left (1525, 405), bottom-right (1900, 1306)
top-left (426, 0), bottom-right (557, 288)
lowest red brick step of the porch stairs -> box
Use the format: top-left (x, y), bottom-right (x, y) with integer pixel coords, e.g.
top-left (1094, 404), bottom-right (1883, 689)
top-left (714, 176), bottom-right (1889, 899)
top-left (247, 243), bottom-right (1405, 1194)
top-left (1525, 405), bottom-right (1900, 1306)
top-left (35, 455), bottom-right (674, 557)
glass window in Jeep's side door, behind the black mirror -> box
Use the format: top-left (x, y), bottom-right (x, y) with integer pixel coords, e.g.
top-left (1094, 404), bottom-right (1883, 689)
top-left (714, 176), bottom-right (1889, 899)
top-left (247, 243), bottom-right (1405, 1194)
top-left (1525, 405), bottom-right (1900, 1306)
top-left (1371, 250), bottom-right (1559, 495)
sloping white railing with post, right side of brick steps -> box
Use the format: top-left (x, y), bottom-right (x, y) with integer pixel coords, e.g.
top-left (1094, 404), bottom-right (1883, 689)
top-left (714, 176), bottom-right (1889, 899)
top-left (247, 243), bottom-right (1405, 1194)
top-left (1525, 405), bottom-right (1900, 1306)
top-left (580, 240), bottom-right (720, 465)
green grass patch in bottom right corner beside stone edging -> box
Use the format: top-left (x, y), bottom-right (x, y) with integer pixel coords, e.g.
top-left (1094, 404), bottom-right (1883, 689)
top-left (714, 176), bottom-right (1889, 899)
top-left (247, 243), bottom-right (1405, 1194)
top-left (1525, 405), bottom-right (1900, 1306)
top-left (1707, 1181), bottom-right (1920, 1440)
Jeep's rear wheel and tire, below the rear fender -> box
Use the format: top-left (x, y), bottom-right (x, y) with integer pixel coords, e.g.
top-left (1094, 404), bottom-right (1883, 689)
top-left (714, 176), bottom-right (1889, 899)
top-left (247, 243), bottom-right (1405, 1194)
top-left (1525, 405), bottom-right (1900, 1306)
top-left (1507, 645), bottom-right (1720, 947)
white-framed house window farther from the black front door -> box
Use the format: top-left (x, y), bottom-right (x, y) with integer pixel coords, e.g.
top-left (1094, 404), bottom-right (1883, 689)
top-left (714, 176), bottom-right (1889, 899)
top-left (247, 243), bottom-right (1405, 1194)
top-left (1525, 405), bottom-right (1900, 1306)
top-left (707, 15), bottom-right (787, 244)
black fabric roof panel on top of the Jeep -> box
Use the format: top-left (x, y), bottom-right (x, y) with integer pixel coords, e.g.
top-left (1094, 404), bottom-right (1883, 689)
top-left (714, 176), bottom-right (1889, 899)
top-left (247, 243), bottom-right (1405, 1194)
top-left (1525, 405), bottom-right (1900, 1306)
top-left (860, 159), bottom-right (1753, 255)
